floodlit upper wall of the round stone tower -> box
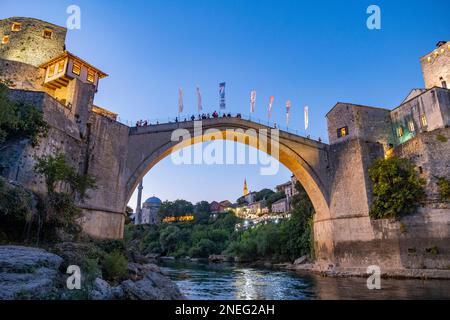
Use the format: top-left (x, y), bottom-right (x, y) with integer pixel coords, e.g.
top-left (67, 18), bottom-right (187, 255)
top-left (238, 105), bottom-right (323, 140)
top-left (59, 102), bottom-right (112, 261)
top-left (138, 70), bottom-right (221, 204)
top-left (0, 17), bottom-right (67, 67)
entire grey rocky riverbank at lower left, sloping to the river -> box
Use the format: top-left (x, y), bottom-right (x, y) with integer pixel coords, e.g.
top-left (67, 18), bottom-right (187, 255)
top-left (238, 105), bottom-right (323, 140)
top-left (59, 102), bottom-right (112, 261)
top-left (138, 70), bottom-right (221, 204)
top-left (0, 245), bottom-right (185, 300)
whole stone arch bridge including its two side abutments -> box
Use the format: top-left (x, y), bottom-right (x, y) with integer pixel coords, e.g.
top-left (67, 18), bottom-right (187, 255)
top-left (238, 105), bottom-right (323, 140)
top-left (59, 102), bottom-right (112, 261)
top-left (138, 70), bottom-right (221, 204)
top-left (81, 117), bottom-right (384, 261)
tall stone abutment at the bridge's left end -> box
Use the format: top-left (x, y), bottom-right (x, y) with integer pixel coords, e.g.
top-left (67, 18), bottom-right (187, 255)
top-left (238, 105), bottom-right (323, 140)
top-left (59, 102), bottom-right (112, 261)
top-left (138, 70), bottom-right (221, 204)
top-left (76, 112), bottom-right (129, 238)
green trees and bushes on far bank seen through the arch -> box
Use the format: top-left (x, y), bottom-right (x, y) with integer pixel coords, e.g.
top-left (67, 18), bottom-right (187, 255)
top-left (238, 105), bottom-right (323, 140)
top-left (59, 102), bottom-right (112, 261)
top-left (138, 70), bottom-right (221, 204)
top-left (125, 184), bottom-right (314, 261)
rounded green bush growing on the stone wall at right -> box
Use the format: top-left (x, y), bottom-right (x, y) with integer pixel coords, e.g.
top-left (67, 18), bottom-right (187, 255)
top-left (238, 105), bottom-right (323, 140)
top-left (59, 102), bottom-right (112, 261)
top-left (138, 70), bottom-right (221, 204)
top-left (369, 157), bottom-right (425, 219)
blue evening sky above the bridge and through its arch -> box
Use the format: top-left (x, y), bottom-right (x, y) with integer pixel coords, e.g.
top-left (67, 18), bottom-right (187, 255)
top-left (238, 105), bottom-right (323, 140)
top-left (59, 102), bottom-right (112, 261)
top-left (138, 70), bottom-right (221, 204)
top-left (0, 0), bottom-right (450, 207)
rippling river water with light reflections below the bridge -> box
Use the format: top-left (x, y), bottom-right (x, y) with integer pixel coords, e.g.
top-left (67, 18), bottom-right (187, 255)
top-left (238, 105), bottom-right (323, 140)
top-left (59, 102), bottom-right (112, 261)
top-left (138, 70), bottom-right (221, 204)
top-left (160, 261), bottom-right (450, 300)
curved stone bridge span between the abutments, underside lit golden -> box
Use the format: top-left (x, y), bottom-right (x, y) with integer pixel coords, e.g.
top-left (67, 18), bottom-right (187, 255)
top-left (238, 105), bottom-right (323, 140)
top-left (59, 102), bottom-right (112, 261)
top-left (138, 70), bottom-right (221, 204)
top-left (125, 118), bottom-right (330, 220)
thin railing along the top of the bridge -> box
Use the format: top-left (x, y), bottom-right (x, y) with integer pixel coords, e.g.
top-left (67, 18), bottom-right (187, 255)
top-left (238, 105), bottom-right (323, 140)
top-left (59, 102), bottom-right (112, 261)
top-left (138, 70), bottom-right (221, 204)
top-left (117, 113), bottom-right (327, 143)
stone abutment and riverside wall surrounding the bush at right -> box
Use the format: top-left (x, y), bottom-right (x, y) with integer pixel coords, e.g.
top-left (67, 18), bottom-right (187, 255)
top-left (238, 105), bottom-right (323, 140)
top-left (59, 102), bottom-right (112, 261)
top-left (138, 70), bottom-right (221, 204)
top-left (320, 128), bottom-right (450, 269)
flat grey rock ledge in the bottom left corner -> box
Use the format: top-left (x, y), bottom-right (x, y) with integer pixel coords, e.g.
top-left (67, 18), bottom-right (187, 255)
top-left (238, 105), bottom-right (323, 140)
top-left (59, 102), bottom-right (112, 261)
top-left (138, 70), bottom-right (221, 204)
top-left (0, 246), bottom-right (63, 299)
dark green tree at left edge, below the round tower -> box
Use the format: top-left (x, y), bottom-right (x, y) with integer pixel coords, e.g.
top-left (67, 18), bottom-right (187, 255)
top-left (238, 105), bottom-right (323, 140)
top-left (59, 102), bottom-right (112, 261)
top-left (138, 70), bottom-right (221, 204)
top-left (0, 84), bottom-right (48, 146)
